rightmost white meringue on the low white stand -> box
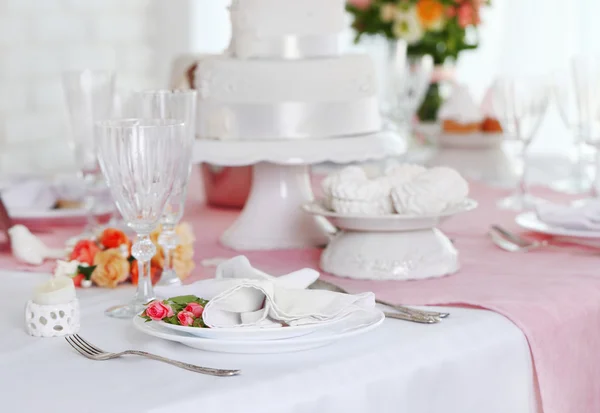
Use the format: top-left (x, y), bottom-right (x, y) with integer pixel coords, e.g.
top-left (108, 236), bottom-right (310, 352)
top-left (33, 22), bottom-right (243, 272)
top-left (391, 167), bottom-right (469, 216)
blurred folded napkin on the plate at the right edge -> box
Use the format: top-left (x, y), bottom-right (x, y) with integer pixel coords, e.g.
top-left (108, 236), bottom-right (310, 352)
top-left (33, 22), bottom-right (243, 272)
top-left (536, 200), bottom-right (600, 231)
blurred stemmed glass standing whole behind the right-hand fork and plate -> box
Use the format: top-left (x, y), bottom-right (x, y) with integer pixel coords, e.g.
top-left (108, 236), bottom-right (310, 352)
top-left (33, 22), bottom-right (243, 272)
top-left (492, 77), bottom-right (550, 211)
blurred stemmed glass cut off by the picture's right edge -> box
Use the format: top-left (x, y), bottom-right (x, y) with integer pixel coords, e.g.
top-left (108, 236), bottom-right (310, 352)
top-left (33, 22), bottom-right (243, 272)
top-left (572, 56), bottom-right (600, 199)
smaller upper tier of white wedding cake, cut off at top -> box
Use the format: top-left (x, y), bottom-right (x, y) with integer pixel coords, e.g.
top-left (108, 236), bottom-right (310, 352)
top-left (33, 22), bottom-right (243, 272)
top-left (230, 0), bottom-right (345, 59)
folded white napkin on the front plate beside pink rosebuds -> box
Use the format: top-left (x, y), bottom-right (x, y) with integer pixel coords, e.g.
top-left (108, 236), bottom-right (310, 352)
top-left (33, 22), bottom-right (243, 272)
top-left (161, 256), bottom-right (375, 328)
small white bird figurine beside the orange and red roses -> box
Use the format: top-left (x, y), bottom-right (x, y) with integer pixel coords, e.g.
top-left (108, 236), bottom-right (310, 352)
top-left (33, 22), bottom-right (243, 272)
top-left (8, 225), bottom-right (65, 265)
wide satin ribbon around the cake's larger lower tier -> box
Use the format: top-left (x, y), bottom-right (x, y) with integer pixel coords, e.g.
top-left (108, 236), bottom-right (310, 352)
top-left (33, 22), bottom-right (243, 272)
top-left (197, 97), bottom-right (381, 140)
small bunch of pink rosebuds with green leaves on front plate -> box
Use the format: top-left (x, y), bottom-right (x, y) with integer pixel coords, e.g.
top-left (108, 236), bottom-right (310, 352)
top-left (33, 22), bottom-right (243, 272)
top-left (140, 295), bottom-right (208, 328)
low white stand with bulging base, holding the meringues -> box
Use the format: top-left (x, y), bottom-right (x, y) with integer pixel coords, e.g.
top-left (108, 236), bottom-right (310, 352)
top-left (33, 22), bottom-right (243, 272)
top-left (303, 199), bottom-right (477, 280)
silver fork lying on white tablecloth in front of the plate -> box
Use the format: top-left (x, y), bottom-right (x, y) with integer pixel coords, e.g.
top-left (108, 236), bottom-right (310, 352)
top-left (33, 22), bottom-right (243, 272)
top-left (65, 334), bottom-right (241, 377)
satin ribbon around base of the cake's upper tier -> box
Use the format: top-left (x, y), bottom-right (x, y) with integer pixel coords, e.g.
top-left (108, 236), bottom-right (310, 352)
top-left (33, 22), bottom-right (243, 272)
top-left (231, 34), bottom-right (341, 60)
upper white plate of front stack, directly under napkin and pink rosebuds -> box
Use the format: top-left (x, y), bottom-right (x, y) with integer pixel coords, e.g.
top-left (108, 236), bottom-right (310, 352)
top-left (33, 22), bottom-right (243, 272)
top-left (157, 319), bottom-right (342, 341)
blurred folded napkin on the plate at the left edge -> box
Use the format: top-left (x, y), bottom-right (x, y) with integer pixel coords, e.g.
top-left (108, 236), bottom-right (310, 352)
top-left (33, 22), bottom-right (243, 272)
top-left (0, 179), bottom-right (58, 212)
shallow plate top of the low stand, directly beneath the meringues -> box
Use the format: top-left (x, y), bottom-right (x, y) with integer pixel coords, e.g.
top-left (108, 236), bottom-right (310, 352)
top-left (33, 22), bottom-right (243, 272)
top-left (302, 199), bottom-right (477, 232)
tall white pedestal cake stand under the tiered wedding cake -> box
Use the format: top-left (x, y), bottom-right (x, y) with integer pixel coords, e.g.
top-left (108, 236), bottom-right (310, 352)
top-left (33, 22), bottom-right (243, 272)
top-left (194, 131), bottom-right (406, 250)
